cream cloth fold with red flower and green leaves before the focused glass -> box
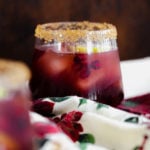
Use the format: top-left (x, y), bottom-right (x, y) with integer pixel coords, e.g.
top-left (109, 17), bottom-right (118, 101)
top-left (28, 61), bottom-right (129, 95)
top-left (32, 96), bottom-right (150, 150)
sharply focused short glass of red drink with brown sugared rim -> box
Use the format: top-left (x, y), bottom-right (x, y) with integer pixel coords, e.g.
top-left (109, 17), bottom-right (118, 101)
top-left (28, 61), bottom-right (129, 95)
top-left (30, 22), bottom-right (123, 106)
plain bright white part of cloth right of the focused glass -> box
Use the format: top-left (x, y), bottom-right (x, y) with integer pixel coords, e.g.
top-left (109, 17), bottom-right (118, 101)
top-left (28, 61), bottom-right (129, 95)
top-left (121, 57), bottom-right (150, 98)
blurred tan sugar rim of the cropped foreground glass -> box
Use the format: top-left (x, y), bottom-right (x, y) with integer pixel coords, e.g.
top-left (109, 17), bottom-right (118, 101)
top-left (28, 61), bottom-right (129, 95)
top-left (0, 58), bottom-right (31, 88)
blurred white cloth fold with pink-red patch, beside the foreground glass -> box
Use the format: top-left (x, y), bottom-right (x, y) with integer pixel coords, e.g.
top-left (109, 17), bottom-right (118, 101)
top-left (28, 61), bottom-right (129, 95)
top-left (30, 109), bottom-right (108, 150)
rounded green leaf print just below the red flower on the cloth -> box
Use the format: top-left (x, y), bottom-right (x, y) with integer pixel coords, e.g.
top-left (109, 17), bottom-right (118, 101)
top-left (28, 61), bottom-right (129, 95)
top-left (79, 133), bottom-right (95, 144)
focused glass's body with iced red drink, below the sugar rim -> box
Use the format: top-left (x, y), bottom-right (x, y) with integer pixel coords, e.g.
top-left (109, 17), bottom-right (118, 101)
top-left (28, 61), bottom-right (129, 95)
top-left (30, 21), bottom-right (123, 106)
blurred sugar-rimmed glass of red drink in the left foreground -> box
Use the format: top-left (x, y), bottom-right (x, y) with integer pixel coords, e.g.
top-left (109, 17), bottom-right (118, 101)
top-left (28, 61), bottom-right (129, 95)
top-left (0, 59), bottom-right (33, 150)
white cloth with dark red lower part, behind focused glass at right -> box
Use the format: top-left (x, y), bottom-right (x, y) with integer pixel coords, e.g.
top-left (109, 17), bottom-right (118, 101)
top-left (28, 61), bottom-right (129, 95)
top-left (118, 57), bottom-right (150, 117)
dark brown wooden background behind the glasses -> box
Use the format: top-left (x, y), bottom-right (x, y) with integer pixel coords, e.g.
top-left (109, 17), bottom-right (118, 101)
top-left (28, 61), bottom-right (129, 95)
top-left (0, 0), bottom-right (150, 66)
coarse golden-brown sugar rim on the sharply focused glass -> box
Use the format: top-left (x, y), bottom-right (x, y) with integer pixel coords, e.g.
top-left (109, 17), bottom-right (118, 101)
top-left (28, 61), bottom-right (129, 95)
top-left (35, 21), bottom-right (117, 42)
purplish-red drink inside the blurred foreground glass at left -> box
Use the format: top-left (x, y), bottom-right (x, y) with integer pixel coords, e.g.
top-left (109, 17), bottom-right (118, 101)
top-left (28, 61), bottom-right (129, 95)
top-left (0, 89), bottom-right (32, 150)
